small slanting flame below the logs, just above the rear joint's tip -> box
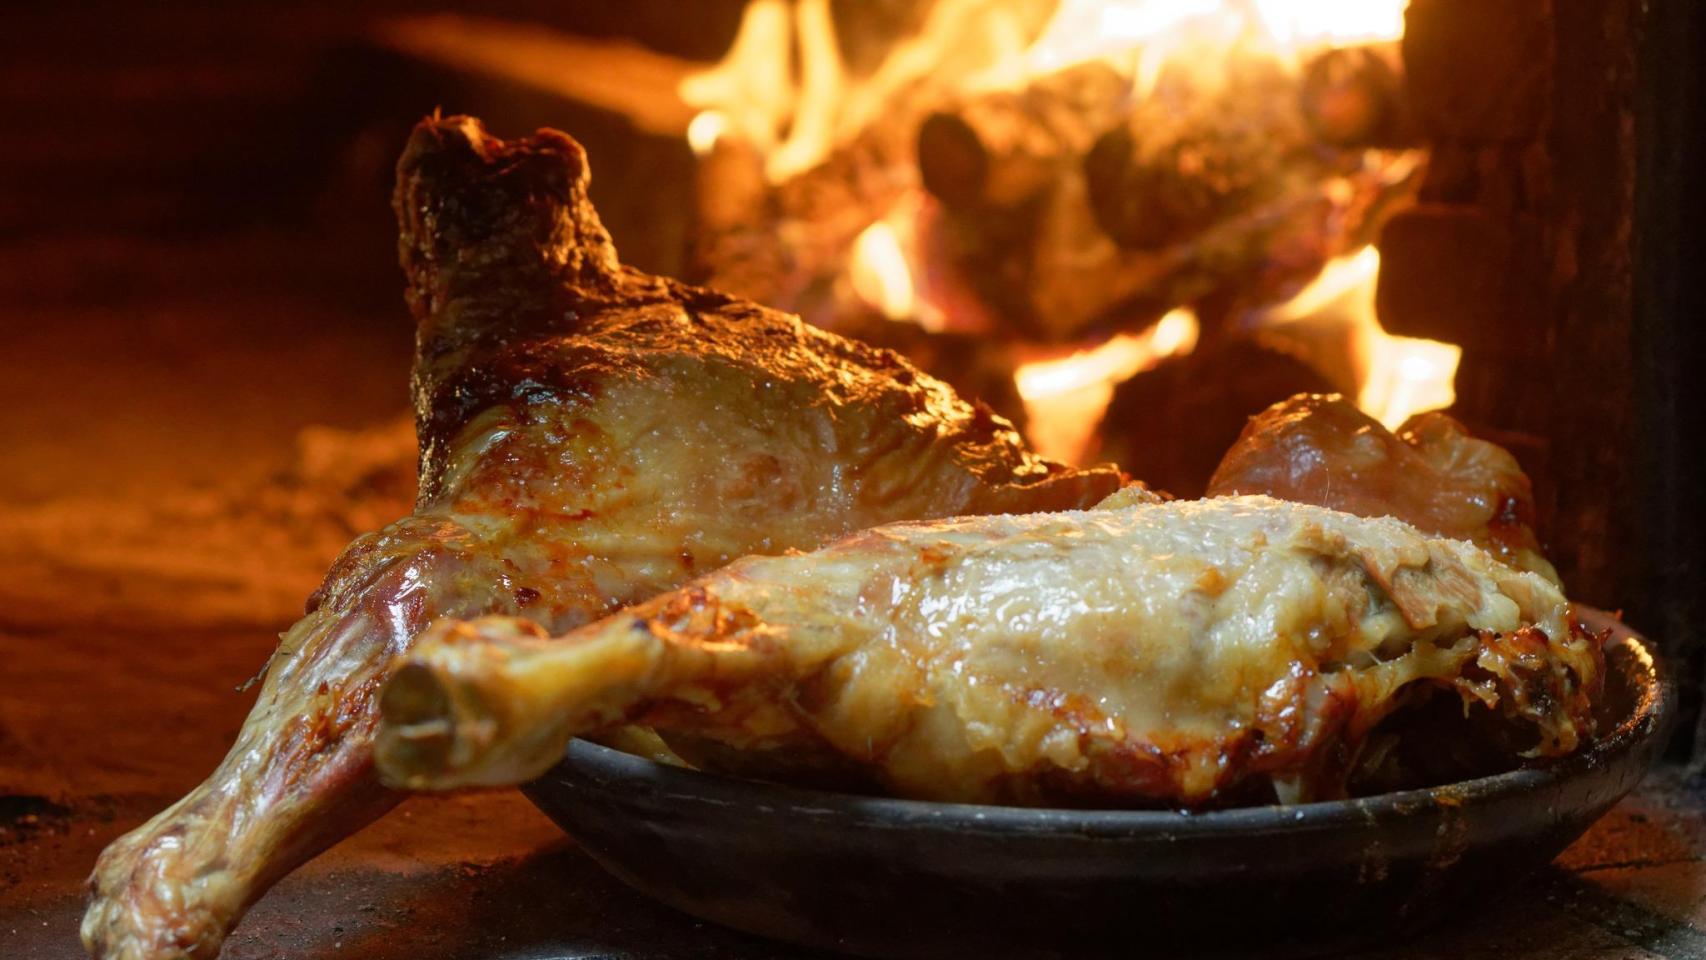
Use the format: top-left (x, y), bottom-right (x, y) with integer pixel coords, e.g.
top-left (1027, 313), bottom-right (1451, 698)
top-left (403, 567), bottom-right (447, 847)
top-left (1013, 307), bottom-right (1198, 462)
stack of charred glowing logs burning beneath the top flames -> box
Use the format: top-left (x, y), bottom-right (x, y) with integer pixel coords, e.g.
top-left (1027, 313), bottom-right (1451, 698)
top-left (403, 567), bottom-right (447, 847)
top-left (696, 9), bottom-right (1407, 354)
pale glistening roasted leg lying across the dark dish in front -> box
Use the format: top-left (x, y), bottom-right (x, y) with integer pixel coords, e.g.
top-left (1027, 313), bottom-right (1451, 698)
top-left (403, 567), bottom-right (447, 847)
top-left (379, 494), bottom-right (1602, 807)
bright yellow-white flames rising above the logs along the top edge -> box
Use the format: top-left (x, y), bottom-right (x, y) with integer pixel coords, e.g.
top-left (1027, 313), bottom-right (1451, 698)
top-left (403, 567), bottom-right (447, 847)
top-left (679, 0), bottom-right (1407, 182)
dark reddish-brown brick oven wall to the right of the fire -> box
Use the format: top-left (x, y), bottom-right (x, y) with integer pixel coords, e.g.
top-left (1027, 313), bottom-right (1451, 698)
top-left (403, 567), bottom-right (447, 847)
top-left (1377, 0), bottom-right (1641, 607)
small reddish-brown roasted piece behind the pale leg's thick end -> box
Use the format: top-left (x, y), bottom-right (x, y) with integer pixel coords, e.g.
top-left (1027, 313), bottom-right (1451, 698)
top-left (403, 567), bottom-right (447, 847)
top-left (1206, 394), bottom-right (1558, 583)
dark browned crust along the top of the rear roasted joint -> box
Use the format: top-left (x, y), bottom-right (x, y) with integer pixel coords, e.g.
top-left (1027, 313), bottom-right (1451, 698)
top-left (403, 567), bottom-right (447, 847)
top-left (392, 116), bottom-right (1123, 508)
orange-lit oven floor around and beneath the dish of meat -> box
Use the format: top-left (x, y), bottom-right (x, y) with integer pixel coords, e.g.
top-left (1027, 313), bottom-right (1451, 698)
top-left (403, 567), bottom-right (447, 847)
top-left (0, 235), bottom-right (1706, 960)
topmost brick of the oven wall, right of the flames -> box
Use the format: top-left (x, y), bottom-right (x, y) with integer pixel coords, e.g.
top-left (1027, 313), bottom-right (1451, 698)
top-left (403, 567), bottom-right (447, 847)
top-left (1404, 0), bottom-right (1552, 142)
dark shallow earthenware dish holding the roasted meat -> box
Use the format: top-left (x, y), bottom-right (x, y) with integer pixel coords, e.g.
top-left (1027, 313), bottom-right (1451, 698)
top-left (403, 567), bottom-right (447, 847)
top-left (525, 610), bottom-right (1675, 957)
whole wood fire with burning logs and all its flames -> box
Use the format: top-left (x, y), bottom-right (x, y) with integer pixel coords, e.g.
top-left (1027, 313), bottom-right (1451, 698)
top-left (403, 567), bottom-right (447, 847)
top-left (681, 0), bottom-right (1457, 460)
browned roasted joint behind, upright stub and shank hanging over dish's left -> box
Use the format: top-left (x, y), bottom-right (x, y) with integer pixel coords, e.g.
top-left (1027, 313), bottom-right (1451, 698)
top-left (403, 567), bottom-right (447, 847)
top-left (84, 118), bottom-right (1119, 960)
